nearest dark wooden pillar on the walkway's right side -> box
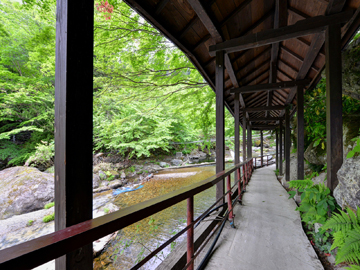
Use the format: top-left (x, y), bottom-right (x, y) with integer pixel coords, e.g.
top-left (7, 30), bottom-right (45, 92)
top-left (325, 24), bottom-right (343, 191)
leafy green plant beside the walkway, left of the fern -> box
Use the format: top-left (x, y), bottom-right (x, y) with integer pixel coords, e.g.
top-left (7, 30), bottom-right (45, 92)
top-left (289, 175), bottom-right (336, 226)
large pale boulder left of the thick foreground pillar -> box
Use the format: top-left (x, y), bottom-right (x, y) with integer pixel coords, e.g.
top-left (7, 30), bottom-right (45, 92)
top-left (0, 167), bottom-right (54, 219)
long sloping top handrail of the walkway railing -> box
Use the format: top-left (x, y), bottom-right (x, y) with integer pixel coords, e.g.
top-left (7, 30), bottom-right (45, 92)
top-left (0, 158), bottom-right (252, 269)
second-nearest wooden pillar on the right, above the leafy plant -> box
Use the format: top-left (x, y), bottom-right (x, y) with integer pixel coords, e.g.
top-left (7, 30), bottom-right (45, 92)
top-left (296, 86), bottom-right (305, 180)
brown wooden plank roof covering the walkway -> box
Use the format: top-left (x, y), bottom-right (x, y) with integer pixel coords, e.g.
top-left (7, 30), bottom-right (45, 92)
top-left (122, 0), bottom-right (360, 129)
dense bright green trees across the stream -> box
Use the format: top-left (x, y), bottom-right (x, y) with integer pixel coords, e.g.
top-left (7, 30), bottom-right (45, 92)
top-left (0, 0), bottom-right (238, 165)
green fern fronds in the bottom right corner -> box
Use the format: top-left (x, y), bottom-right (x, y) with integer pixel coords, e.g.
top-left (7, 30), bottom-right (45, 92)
top-left (324, 207), bottom-right (360, 264)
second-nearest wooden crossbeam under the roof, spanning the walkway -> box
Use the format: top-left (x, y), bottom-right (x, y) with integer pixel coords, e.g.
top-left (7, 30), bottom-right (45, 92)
top-left (230, 79), bottom-right (310, 94)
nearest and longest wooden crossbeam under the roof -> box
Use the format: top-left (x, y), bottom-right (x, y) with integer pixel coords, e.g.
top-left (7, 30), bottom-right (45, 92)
top-left (208, 11), bottom-right (353, 56)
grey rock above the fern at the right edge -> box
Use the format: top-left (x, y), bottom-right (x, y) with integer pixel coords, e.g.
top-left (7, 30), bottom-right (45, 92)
top-left (334, 156), bottom-right (360, 209)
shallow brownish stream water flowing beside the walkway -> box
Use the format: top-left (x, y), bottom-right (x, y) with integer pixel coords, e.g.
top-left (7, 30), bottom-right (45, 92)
top-left (94, 164), bottom-right (233, 270)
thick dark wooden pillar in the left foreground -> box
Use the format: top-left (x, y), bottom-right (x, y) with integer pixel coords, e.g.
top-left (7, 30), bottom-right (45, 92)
top-left (55, 0), bottom-right (94, 270)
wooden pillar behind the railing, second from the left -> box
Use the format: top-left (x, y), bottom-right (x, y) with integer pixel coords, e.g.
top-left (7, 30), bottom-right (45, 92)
top-left (215, 51), bottom-right (225, 204)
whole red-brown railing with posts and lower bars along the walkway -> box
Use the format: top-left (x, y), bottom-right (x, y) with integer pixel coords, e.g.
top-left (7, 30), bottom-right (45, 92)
top-left (0, 159), bottom-right (254, 270)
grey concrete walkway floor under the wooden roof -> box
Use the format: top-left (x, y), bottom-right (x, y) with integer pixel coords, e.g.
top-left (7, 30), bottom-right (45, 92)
top-left (195, 165), bottom-right (324, 270)
